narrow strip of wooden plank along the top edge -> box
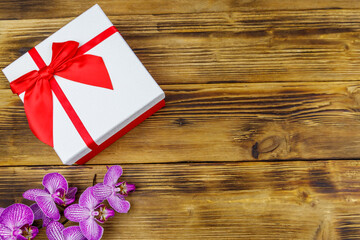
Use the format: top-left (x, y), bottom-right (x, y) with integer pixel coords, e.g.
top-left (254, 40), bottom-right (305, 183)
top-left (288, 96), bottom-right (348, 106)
top-left (0, 0), bottom-right (360, 19)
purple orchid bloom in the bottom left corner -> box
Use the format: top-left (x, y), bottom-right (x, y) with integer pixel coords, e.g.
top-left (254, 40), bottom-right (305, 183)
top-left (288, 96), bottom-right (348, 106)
top-left (0, 203), bottom-right (39, 240)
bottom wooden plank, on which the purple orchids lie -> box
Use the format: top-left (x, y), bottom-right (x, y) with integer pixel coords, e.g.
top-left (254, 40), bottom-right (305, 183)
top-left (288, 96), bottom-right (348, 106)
top-left (0, 161), bottom-right (360, 239)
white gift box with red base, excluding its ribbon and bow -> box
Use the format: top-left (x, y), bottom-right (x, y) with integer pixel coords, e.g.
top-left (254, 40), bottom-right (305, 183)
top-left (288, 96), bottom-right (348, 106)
top-left (3, 5), bottom-right (165, 164)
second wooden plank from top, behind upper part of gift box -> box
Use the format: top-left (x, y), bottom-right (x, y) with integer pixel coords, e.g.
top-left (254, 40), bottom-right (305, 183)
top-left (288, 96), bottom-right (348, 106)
top-left (0, 10), bottom-right (360, 88)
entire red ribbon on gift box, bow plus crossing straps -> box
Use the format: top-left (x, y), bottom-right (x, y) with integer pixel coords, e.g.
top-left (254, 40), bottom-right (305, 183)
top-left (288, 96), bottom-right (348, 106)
top-left (10, 26), bottom-right (117, 149)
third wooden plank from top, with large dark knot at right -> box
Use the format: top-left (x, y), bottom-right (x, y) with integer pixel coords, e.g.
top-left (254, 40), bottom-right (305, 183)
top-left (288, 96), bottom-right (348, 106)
top-left (0, 82), bottom-right (360, 165)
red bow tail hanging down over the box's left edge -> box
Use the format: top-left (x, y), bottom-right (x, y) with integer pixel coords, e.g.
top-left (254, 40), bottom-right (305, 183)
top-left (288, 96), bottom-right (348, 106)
top-left (24, 80), bottom-right (54, 147)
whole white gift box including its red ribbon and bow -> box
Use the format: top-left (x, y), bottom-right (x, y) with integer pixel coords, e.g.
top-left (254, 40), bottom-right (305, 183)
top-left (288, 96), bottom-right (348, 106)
top-left (3, 5), bottom-right (165, 164)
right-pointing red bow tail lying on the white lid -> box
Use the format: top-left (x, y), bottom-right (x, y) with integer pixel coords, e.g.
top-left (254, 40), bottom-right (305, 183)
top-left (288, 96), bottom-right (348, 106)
top-left (55, 54), bottom-right (113, 90)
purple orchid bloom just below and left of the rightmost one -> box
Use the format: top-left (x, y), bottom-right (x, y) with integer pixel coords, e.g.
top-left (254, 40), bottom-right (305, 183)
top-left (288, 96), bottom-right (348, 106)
top-left (64, 187), bottom-right (115, 240)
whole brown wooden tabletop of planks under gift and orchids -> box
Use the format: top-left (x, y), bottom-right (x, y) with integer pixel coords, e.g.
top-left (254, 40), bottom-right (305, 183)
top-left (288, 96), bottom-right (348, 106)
top-left (0, 0), bottom-right (360, 240)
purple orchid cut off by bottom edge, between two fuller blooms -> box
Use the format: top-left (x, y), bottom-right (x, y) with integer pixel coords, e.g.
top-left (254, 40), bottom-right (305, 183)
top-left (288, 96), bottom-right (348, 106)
top-left (46, 222), bottom-right (87, 240)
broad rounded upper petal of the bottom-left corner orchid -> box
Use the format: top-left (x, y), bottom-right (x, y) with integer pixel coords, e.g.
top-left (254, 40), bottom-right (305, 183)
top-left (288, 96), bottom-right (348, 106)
top-left (1, 203), bottom-right (34, 229)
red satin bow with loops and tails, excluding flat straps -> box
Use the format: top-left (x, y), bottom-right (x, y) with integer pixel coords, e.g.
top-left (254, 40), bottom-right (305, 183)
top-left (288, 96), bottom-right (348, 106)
top-left (10, 41), bottom-right (113, 147)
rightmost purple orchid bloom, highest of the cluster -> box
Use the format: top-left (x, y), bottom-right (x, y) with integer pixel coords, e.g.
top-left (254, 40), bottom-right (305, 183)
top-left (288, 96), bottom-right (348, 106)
top-left (93, 165), bottom-right (135, 213)
